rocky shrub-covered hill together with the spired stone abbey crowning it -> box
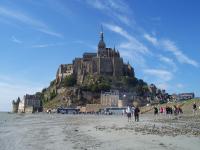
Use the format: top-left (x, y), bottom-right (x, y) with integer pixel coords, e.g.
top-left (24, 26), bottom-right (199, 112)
top-left (38, 32), bottom-right (168, 108)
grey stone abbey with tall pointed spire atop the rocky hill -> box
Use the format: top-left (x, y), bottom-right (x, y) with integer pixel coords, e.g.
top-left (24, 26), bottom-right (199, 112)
top-left (56, 32), bottom-right (134, 84)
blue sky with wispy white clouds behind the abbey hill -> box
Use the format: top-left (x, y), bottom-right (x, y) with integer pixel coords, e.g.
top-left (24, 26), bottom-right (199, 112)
top-left (0, 0), bottom-right (200, 111)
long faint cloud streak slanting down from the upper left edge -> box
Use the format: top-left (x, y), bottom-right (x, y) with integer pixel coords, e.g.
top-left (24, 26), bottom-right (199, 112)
top-left (0, 6), bottom-right (62, 37)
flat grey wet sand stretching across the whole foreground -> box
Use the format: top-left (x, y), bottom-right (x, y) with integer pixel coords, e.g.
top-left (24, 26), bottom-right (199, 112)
top-left (0, 113), bottom-right (200, 150)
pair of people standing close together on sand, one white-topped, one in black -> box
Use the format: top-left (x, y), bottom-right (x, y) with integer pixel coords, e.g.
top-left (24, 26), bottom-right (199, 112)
top-left (124, 106), bottom-right (140, 122)
